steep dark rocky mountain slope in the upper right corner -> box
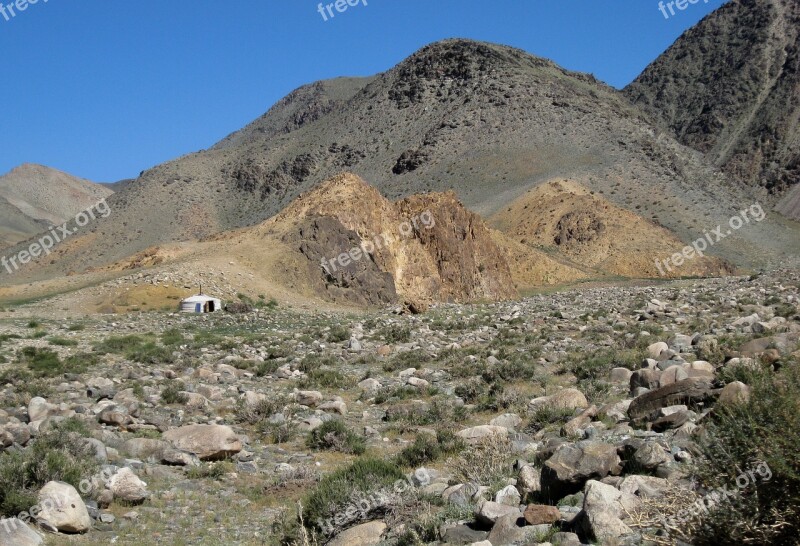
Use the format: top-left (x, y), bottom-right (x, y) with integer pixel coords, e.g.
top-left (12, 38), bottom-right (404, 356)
top-left (624, 0), bottom-right (800, 202)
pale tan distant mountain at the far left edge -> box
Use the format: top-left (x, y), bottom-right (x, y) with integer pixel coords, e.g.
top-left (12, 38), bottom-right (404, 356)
top-left (0, 163), bottom-right (113, 246)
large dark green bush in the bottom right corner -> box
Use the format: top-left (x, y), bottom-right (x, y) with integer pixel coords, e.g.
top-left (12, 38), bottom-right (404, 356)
top-left (693, 362), bottom-right (800, 545)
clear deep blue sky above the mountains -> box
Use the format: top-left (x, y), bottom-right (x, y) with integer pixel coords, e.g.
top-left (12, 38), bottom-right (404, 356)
top-left (0, 0), bottom-right (724, 182)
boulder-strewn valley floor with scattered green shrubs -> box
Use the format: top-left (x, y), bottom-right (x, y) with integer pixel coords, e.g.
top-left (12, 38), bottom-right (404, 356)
top-left (0, 270), bottom-right (800, 546)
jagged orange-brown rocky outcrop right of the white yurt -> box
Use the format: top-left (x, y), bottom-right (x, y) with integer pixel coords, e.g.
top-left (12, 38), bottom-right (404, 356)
top-left (266, 174), bottom-right (517, 309)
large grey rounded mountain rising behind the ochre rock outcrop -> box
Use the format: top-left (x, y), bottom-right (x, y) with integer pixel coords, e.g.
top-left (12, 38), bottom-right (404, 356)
top-left (3, 36), bottom-right (800, 292)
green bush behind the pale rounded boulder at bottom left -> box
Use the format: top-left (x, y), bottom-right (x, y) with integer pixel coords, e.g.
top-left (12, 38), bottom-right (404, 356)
top-left (0, 428), bottom-right (97, 517)
